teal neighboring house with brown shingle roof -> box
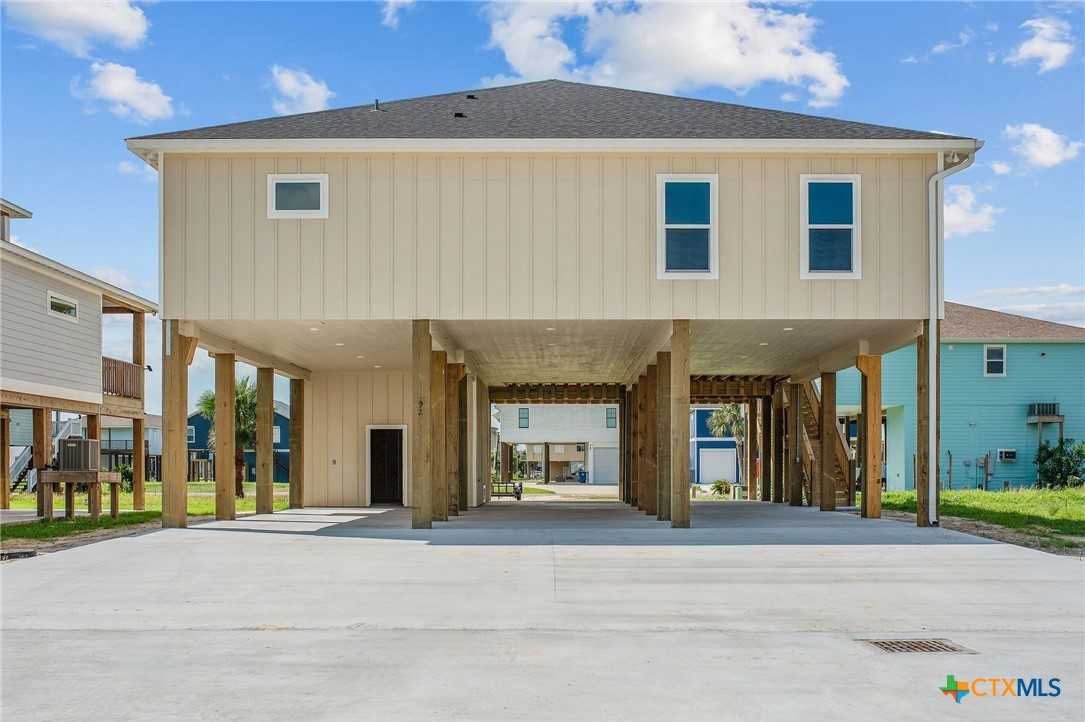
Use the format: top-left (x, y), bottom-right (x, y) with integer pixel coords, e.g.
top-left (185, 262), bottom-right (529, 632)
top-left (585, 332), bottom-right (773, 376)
top-left (837, 302), bottom-right (1085, 490)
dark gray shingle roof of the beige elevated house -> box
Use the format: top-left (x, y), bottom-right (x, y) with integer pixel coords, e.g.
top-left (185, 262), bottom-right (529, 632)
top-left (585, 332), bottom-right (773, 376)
top-left (129, 80), bottom-right (976, 140)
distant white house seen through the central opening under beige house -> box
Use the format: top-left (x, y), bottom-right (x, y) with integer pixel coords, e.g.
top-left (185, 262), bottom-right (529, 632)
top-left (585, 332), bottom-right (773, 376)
top-left (497, 404), bottom-right (618, 484)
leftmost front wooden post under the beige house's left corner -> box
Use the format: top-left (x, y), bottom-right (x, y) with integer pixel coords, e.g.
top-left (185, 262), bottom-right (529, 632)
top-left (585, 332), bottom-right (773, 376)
top-left (162, 319), bottom-right (195, 529)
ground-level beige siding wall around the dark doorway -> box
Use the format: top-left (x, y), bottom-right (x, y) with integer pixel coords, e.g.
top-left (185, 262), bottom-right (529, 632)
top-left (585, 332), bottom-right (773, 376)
top-left (305, 371), bottom-right (411, 506)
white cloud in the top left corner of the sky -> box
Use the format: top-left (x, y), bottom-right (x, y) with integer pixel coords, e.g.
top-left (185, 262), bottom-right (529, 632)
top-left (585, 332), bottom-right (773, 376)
top-left (4, 0), bottom-right (149, 58)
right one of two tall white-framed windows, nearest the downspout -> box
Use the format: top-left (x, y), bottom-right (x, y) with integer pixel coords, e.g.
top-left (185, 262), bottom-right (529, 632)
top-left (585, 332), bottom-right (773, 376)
top-left (799, 173), bottom-right (863, 280)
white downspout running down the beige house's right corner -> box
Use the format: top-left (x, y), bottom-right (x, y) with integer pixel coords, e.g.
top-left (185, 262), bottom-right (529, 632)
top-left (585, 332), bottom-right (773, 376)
top-left (912, 140), bottom-right (983, 527)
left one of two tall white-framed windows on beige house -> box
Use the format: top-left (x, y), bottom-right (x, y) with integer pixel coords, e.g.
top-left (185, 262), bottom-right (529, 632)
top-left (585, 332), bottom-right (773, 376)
top-left (655, 173), bottom-right (719, 280)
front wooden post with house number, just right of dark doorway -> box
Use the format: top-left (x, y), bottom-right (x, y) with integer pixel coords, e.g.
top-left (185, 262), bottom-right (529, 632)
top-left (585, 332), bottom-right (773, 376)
top-left (410, 319), bottom-right (429, 529)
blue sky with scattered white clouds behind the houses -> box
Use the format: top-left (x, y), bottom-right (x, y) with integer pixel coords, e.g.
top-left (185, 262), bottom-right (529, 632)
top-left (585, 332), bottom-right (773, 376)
top-left (0, 0), bottom-right (1085, 410)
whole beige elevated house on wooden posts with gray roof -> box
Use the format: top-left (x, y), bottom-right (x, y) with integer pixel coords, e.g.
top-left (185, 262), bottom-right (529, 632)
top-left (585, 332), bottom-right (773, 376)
top-left (127, 80), bottom-right (982, 528)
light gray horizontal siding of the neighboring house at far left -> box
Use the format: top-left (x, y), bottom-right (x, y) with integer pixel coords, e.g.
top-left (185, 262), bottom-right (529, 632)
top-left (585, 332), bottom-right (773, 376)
top-left (0, 261), bottom-right (102, 404)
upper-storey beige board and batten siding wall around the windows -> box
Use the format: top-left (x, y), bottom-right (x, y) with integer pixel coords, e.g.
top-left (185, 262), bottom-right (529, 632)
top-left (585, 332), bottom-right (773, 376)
top-left (162, 153), bottom-right (937, 320)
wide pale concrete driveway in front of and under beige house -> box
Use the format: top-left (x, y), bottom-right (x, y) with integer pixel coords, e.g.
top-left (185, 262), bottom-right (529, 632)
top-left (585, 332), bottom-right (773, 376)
top-left (0, 502), bottom-right (1085, 722)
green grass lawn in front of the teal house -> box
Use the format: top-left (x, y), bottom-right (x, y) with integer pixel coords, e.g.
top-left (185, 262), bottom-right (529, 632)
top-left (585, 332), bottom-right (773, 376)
top-left (882, 487), bottom-right (1085, 546)
